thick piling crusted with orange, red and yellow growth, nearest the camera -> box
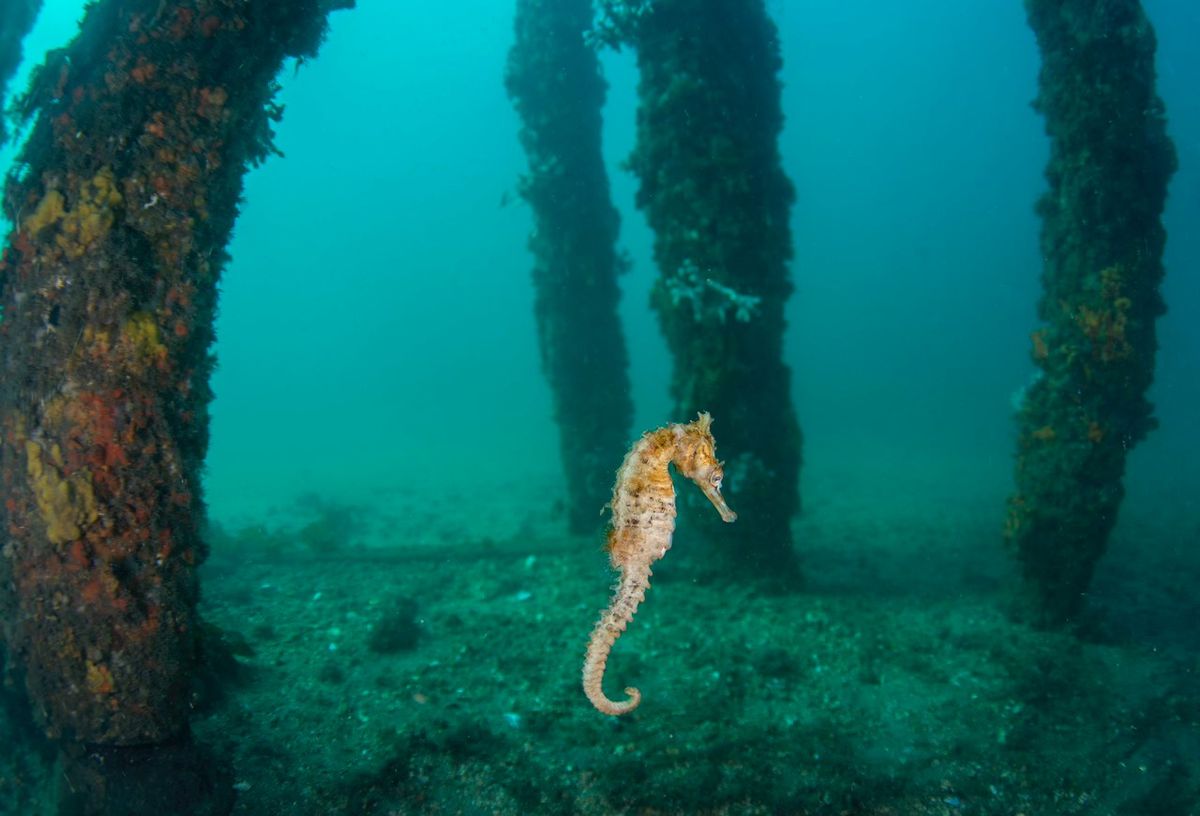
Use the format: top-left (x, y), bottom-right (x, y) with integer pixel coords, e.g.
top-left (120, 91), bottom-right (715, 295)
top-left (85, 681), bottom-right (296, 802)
top-left (0, 0), bottom-right (350, 814)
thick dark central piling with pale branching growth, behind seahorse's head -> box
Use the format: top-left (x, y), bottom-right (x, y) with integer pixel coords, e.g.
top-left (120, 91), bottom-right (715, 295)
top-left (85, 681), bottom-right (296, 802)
top-left (599, 0), bottom-right (800, 580)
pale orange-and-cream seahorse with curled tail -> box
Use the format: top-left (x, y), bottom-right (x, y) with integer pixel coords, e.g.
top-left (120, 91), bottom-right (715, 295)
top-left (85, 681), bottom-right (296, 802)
top-left (583, 413), bottom-right (738, 715)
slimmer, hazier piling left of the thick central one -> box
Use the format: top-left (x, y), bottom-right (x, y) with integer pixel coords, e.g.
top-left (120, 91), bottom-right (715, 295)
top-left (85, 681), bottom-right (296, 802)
top-left (505, 0), bottom-right (634, 533)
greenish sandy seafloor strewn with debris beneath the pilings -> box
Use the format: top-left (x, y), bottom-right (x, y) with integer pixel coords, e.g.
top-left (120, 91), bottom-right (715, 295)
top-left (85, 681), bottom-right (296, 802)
top-left (0, 446), bottom-right (1200, 816)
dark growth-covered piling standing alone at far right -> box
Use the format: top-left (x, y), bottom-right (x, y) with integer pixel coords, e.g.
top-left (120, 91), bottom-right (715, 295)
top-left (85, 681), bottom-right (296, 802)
top-left (1006, 0), bottom-right (1175, 625)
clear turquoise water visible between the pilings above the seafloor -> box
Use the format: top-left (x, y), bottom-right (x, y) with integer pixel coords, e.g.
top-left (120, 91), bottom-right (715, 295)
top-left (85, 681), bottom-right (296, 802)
top-left (4, 0), bottom-right (1200, 516)
